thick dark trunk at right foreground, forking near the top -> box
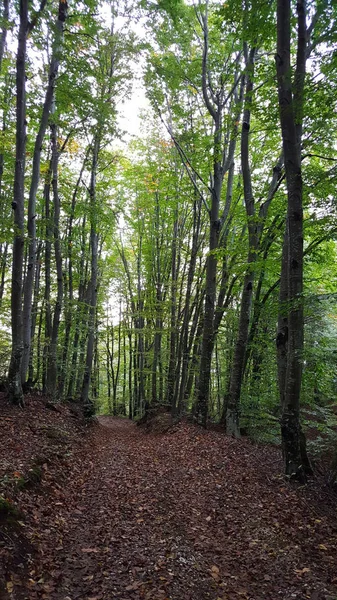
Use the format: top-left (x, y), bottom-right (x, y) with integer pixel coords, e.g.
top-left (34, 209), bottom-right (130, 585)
top-left (276, 0), bottom-right (307, 481)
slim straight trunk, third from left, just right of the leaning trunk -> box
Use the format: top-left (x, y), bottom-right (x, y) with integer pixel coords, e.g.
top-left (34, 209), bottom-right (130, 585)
top-left (46, 123), bottom-right (63, 396)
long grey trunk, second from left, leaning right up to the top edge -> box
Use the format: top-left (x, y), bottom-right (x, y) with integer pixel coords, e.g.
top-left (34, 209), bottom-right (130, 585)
top-left (21, 0), bottom-right (68, 383)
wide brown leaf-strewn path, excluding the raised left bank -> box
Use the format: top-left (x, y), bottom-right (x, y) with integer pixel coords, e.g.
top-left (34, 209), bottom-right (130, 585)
top-left (48, 417), bottom-right (337, 600)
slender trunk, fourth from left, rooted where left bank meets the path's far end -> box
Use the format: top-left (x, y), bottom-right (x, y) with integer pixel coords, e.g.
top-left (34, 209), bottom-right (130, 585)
top-left (81, 135), bottom-right (100, 415)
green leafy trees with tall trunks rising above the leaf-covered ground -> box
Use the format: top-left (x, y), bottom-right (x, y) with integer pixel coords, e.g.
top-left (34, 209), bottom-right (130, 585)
top-left (0, 0), bottom-right (337, 480)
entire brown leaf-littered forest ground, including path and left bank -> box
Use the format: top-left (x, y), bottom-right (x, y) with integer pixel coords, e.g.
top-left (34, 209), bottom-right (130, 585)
top-left (0, 397), bottom-right (337, 600)
